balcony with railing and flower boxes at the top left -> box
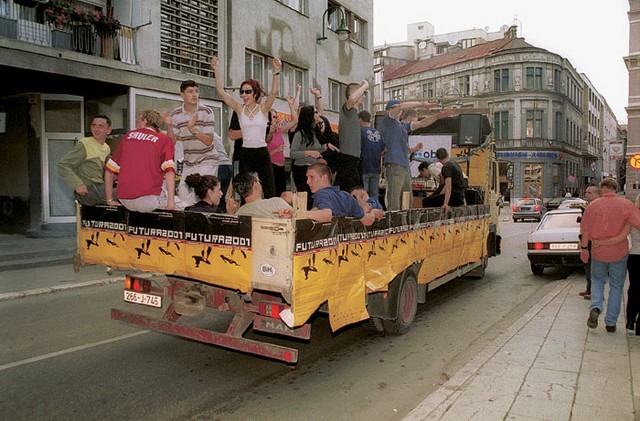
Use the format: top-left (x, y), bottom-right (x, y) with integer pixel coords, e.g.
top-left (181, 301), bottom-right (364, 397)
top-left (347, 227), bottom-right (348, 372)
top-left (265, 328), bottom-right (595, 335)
top-left (0, 0), bottom-right (136, 64)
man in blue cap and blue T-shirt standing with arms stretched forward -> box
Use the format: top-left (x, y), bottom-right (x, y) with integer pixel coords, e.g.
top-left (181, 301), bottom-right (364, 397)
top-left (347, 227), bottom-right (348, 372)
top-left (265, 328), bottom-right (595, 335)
top-left (380, 99), bottom-right (453, 210)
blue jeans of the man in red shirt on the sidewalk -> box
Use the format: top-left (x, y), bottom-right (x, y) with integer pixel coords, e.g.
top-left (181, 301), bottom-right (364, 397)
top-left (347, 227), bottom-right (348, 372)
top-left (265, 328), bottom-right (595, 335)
top-left (589, 255), bottom-right (629, 326)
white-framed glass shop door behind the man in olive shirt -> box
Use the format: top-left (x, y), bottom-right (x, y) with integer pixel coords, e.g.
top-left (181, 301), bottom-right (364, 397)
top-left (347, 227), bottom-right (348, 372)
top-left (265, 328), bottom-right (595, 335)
top-left (42, 94), bottom-right (85, 223)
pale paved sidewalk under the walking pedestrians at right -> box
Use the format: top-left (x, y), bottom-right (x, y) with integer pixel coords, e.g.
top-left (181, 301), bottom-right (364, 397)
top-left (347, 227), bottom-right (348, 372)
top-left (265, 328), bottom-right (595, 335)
top-left (405, 274), bottom-right (640, 421)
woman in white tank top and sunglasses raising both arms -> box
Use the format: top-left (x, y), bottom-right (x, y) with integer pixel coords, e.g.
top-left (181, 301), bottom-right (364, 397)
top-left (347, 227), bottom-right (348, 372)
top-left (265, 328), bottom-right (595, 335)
top-left (211, 56), bottom-right (282, 199)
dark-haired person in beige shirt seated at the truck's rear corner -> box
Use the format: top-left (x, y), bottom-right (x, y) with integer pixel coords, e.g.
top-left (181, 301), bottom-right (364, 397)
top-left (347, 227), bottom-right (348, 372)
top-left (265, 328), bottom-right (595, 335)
top-left (227, 171), bottom-right (293, 219)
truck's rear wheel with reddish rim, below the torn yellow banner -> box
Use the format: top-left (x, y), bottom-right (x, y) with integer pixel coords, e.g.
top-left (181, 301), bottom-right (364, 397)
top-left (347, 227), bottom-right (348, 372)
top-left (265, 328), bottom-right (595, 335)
top-left (382, 274), bottom-right (418, 335)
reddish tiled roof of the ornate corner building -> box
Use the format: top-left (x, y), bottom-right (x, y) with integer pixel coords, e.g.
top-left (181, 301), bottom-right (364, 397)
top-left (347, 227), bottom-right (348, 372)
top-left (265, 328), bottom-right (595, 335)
top-left (384, 38), bottom-right (546, 80)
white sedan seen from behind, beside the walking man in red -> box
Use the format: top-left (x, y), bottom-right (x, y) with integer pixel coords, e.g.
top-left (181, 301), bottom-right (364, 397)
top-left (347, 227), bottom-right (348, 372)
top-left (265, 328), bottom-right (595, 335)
top-left (527, 209), bottom-right (582, 275)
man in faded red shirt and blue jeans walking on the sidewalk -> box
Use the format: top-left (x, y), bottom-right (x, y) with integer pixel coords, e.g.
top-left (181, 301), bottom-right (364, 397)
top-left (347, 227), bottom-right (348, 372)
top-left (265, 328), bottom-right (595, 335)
top-left (580, 178), bottom-right (640, 332)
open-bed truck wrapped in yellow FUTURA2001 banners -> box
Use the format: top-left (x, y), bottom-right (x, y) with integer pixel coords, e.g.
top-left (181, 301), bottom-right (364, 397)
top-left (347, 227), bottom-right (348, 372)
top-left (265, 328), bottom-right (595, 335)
top-left (76, 113), bottom-right (500, 364)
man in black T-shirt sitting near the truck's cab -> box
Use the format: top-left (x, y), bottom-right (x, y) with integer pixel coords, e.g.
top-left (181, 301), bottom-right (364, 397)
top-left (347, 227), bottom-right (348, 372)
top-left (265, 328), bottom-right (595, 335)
top-left (422, 148), bottom-right (466, 211)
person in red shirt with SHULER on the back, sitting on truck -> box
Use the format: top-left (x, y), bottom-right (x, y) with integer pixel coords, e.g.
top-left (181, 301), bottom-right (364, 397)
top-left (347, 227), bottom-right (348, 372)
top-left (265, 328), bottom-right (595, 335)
top-left (104, 110), bottom-right (176, 212)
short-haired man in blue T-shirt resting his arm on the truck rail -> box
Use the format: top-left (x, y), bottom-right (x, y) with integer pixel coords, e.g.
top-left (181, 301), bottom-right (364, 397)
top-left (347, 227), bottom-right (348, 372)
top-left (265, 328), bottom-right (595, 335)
top-left (307, 163), bottom-right (384, 226)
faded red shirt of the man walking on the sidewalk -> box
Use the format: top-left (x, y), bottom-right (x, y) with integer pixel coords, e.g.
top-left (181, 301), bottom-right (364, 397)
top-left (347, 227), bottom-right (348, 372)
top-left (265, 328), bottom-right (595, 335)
top-left (580, 193), bottom-right (640, 263)
